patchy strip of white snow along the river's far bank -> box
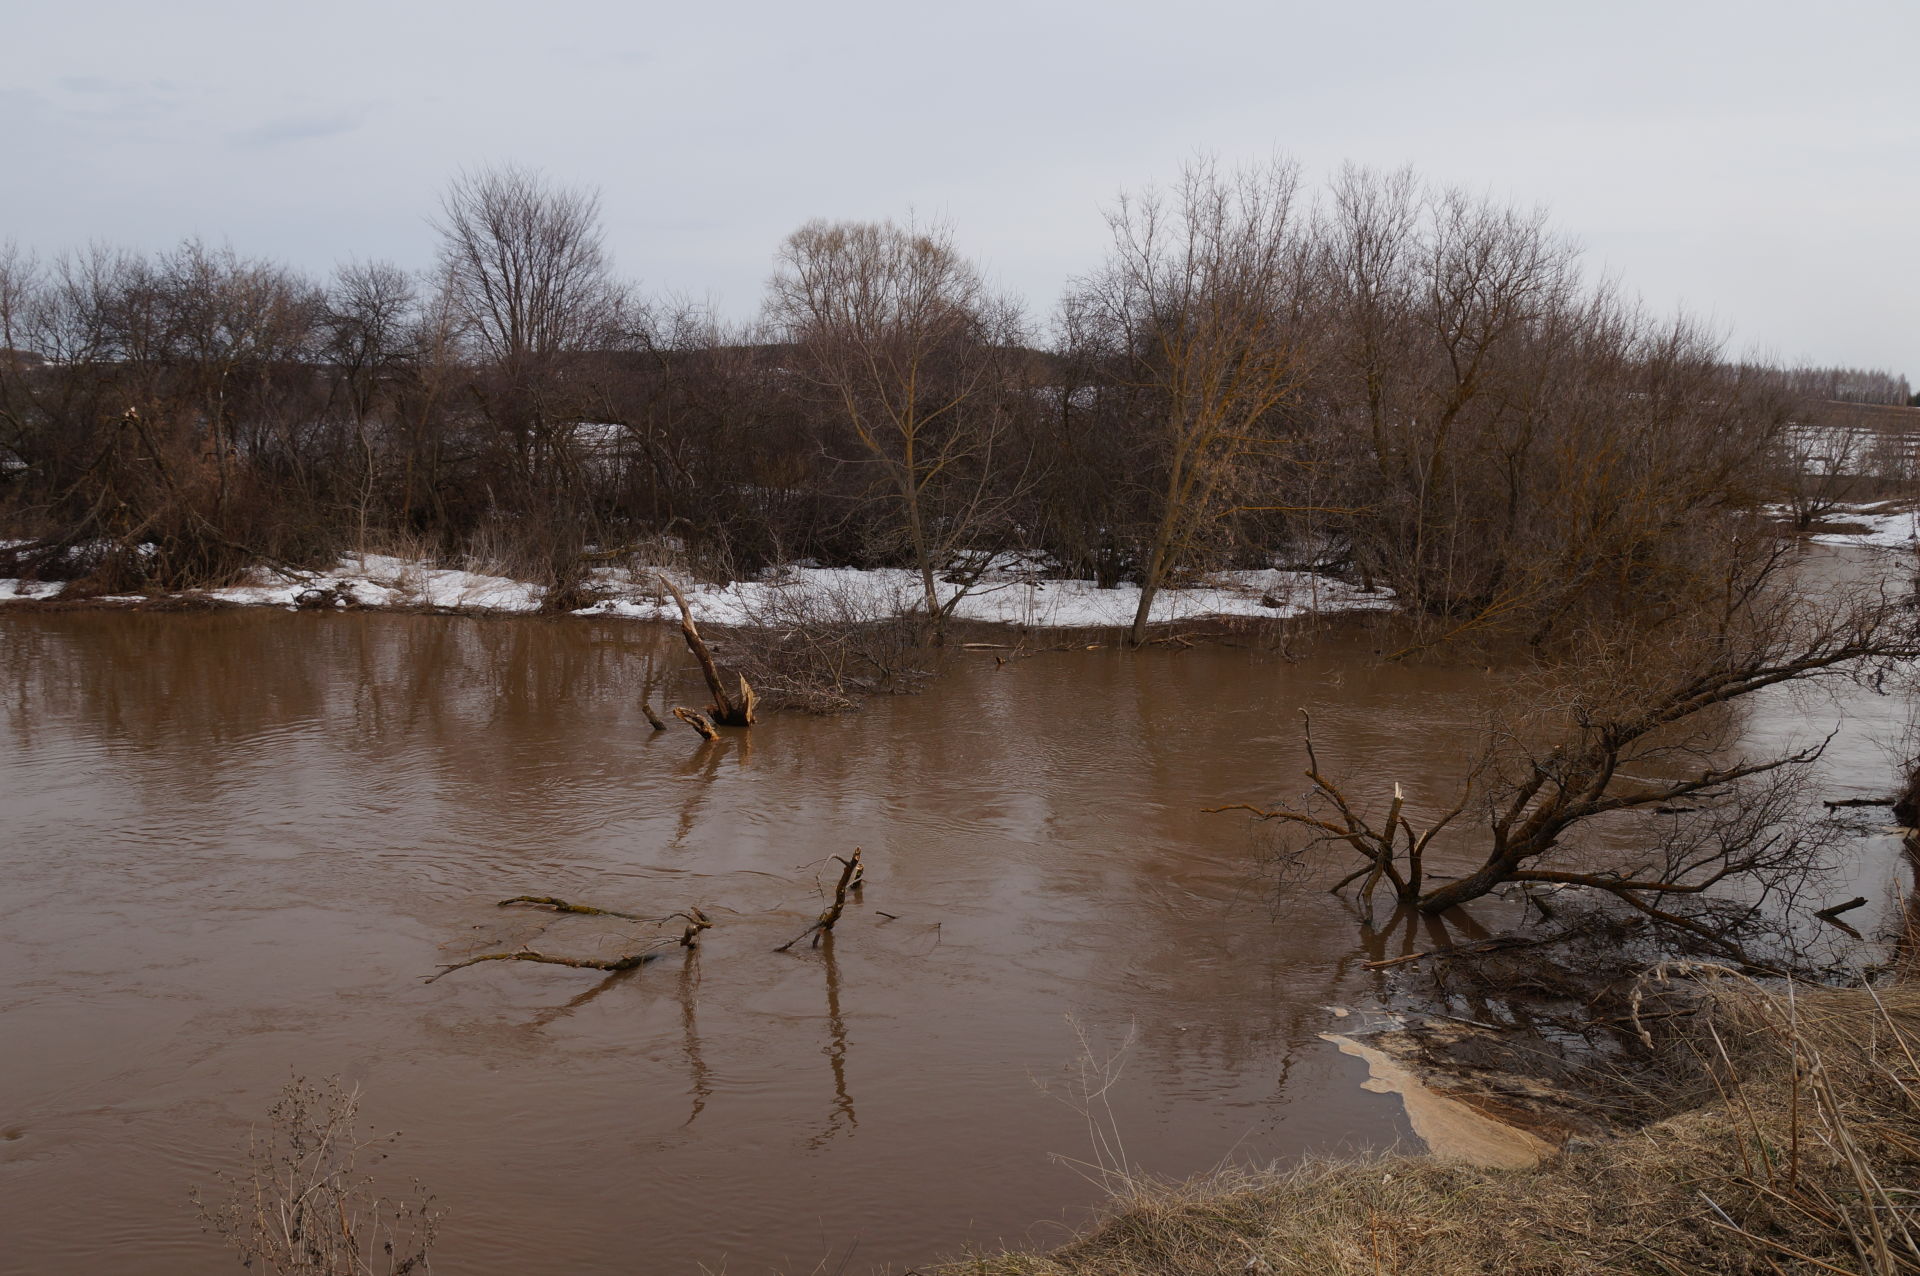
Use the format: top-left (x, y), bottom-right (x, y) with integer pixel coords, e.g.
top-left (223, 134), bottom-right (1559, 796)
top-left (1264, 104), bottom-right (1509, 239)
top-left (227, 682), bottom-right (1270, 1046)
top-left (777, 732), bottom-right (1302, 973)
top-left (0, 555), bottom-right (1392, 629)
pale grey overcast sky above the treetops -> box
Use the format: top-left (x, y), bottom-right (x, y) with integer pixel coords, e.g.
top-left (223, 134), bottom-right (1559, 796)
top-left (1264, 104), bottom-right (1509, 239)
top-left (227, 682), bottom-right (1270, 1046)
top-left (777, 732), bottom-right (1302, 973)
top-left (0, 0), bottom-right (1920, 380)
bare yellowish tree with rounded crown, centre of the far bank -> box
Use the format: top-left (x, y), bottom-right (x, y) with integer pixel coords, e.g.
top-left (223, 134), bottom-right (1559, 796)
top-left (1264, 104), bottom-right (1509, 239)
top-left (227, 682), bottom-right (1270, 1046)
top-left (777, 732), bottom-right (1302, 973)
top-left (768, 221), bottom-right (1025, 639)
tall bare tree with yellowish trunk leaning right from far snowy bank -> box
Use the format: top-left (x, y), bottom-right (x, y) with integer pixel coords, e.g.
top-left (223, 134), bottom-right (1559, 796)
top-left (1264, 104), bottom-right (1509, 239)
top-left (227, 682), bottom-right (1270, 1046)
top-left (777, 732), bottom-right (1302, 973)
top-left (1064, 161), bottom-right (1309, 643)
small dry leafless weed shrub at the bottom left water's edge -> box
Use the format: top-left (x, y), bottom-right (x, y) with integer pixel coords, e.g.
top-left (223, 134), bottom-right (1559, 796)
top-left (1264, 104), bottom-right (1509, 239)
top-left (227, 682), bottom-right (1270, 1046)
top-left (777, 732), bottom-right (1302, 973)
top-left (192, 1076), bottom-right (440, 1276)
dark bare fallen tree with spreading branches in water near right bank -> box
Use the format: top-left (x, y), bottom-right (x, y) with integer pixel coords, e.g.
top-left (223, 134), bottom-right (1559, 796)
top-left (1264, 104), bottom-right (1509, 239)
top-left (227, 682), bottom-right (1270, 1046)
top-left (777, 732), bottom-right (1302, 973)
top-left (1210, 547), bottom-right (1920, 961)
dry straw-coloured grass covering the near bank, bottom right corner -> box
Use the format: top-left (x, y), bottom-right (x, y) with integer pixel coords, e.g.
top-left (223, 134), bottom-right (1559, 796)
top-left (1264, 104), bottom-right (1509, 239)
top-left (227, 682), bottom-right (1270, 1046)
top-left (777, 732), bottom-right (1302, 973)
top-left (948, 965), bottom-right (1920, 1276)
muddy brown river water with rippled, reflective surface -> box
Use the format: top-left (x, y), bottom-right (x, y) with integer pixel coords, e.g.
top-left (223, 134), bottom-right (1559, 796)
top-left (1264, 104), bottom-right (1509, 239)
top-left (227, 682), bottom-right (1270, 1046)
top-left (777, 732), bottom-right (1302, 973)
top-left (0, 598), bottom-right (1897, 1276)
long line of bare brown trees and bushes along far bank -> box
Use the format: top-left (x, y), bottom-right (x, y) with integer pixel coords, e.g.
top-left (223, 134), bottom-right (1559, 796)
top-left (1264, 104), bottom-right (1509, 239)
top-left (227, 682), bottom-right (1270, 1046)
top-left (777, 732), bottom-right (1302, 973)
top-left (0, 163), bottom-right (1891, 641)
